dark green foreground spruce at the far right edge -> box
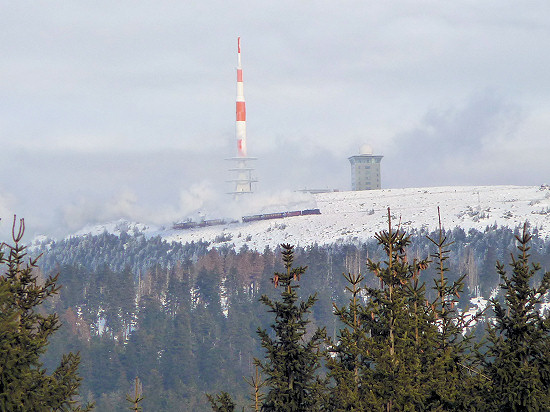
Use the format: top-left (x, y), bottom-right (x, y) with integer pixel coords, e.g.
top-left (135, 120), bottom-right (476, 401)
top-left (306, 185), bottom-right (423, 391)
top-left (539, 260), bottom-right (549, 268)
top-left (484, 225), bottom-right (550, 411)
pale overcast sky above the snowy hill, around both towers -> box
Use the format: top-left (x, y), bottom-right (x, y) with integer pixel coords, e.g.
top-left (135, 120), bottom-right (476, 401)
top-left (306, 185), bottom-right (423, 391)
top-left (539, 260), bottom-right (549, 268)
top-left (0, 0), bottom-right (550, 236)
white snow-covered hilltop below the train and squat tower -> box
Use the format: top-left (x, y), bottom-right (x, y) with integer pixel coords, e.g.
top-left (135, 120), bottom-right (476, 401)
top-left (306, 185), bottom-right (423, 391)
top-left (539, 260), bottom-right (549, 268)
top-left (61, 185), bottom-right (550, 250)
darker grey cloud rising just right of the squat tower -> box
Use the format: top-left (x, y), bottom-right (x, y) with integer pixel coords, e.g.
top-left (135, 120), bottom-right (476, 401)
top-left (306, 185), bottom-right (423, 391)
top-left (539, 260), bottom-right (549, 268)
top-left (385, 91), bottom-right (536, 186)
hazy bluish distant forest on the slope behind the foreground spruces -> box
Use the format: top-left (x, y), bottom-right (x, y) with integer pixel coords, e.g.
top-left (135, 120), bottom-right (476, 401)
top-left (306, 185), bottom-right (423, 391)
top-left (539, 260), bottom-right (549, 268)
top-left (33, 224), bottom-right (550, 411)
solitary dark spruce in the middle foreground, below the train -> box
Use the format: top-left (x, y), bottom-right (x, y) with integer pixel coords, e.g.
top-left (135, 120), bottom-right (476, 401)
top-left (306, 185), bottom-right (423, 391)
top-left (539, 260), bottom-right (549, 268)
top-left (255, 244), bottom-right (326, 412)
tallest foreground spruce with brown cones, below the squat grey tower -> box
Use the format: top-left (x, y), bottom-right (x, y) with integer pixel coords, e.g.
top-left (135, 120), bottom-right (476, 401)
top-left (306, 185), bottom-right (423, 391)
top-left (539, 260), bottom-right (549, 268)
top-left (362, 209), bottom-right (437, 411)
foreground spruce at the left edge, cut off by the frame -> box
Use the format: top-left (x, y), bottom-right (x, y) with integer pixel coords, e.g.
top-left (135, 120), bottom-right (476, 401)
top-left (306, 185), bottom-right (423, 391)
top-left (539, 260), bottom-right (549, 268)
top-left (0, 218), bottom-right (91, 412)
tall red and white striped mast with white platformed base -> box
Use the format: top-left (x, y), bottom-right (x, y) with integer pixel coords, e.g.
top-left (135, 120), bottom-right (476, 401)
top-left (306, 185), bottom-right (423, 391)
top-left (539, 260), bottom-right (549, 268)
top-left (228, 37), bottom-right (256, 195)
